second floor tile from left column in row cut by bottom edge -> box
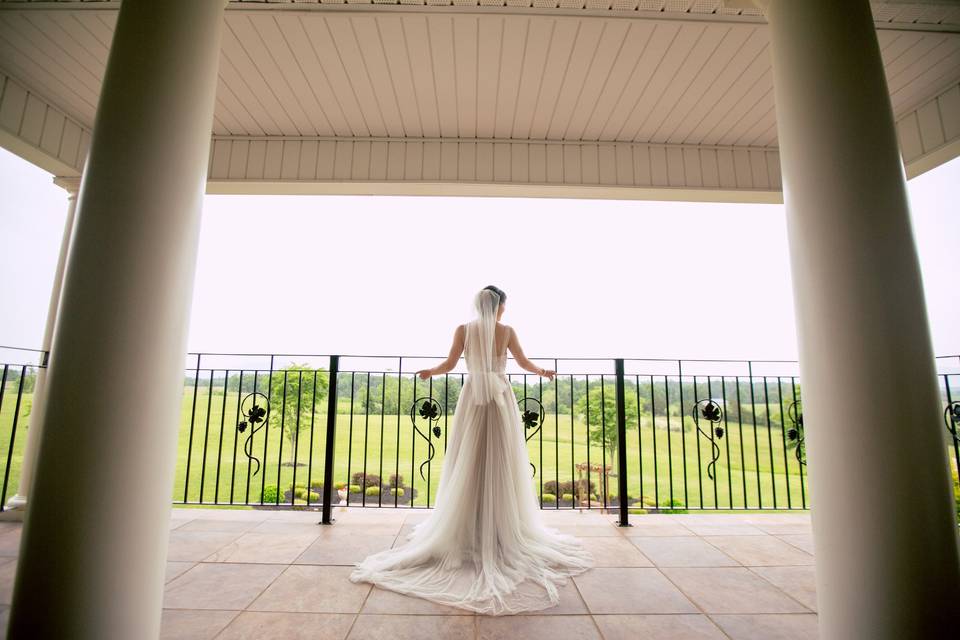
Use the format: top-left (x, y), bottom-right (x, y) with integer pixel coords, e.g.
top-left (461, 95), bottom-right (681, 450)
top-left (217, 611), bottom-right (354, 640)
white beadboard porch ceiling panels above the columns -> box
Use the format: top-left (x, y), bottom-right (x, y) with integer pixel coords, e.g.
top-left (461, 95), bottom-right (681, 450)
top-left (0, 0), bottom-right (960, 194)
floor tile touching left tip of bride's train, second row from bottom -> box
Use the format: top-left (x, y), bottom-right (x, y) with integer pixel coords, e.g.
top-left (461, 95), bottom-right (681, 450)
top-left (247, 565), bottom-right (370, 613)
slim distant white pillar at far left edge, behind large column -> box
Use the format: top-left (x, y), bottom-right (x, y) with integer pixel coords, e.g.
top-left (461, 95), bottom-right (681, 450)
top-left (6, 177), bottom-right (80, 509)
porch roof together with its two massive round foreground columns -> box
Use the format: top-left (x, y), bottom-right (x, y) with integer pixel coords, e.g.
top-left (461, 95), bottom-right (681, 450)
top-left (0, 0), bottom-right (960, 638)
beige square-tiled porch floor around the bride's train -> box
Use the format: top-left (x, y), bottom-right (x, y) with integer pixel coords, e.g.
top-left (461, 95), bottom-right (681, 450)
top-left (0, 508), bottom-right (817, 640)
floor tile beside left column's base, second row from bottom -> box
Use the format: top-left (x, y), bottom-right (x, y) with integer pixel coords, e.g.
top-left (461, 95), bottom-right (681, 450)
top-left (163, 563), bottom-right (284, 609)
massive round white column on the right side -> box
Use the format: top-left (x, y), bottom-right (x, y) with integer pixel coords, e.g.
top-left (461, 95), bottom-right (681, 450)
top-left (766, 0), bottom-right (960, 640)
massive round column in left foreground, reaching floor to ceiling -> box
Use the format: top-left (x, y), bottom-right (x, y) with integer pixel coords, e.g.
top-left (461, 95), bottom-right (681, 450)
top-left (9, 0), bottom-right (225, 639)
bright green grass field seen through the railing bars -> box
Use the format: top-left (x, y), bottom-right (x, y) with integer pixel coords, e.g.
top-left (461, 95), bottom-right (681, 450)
top-left (0, 386), bottom-right (956, 509)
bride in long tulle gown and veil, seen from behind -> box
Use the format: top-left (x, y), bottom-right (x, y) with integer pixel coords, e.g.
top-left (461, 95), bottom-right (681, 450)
top-left (350, 286), bottom-right (595, 615)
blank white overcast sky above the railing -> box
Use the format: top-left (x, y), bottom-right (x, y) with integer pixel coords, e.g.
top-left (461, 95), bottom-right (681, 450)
top-left (0, 150), bottom-right (960, 359)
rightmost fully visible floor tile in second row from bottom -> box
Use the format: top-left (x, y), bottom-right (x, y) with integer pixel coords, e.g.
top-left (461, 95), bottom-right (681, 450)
top-left (663, 567), bottom-right (808, 613)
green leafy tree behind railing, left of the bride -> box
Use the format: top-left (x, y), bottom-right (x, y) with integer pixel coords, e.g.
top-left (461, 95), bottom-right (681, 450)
top-left (266, 364), bottom-right (330, 464)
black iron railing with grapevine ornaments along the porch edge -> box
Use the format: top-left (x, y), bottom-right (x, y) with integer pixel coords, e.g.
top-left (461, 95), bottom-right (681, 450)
top-left (0, 350), bottom-right (960, 523)
